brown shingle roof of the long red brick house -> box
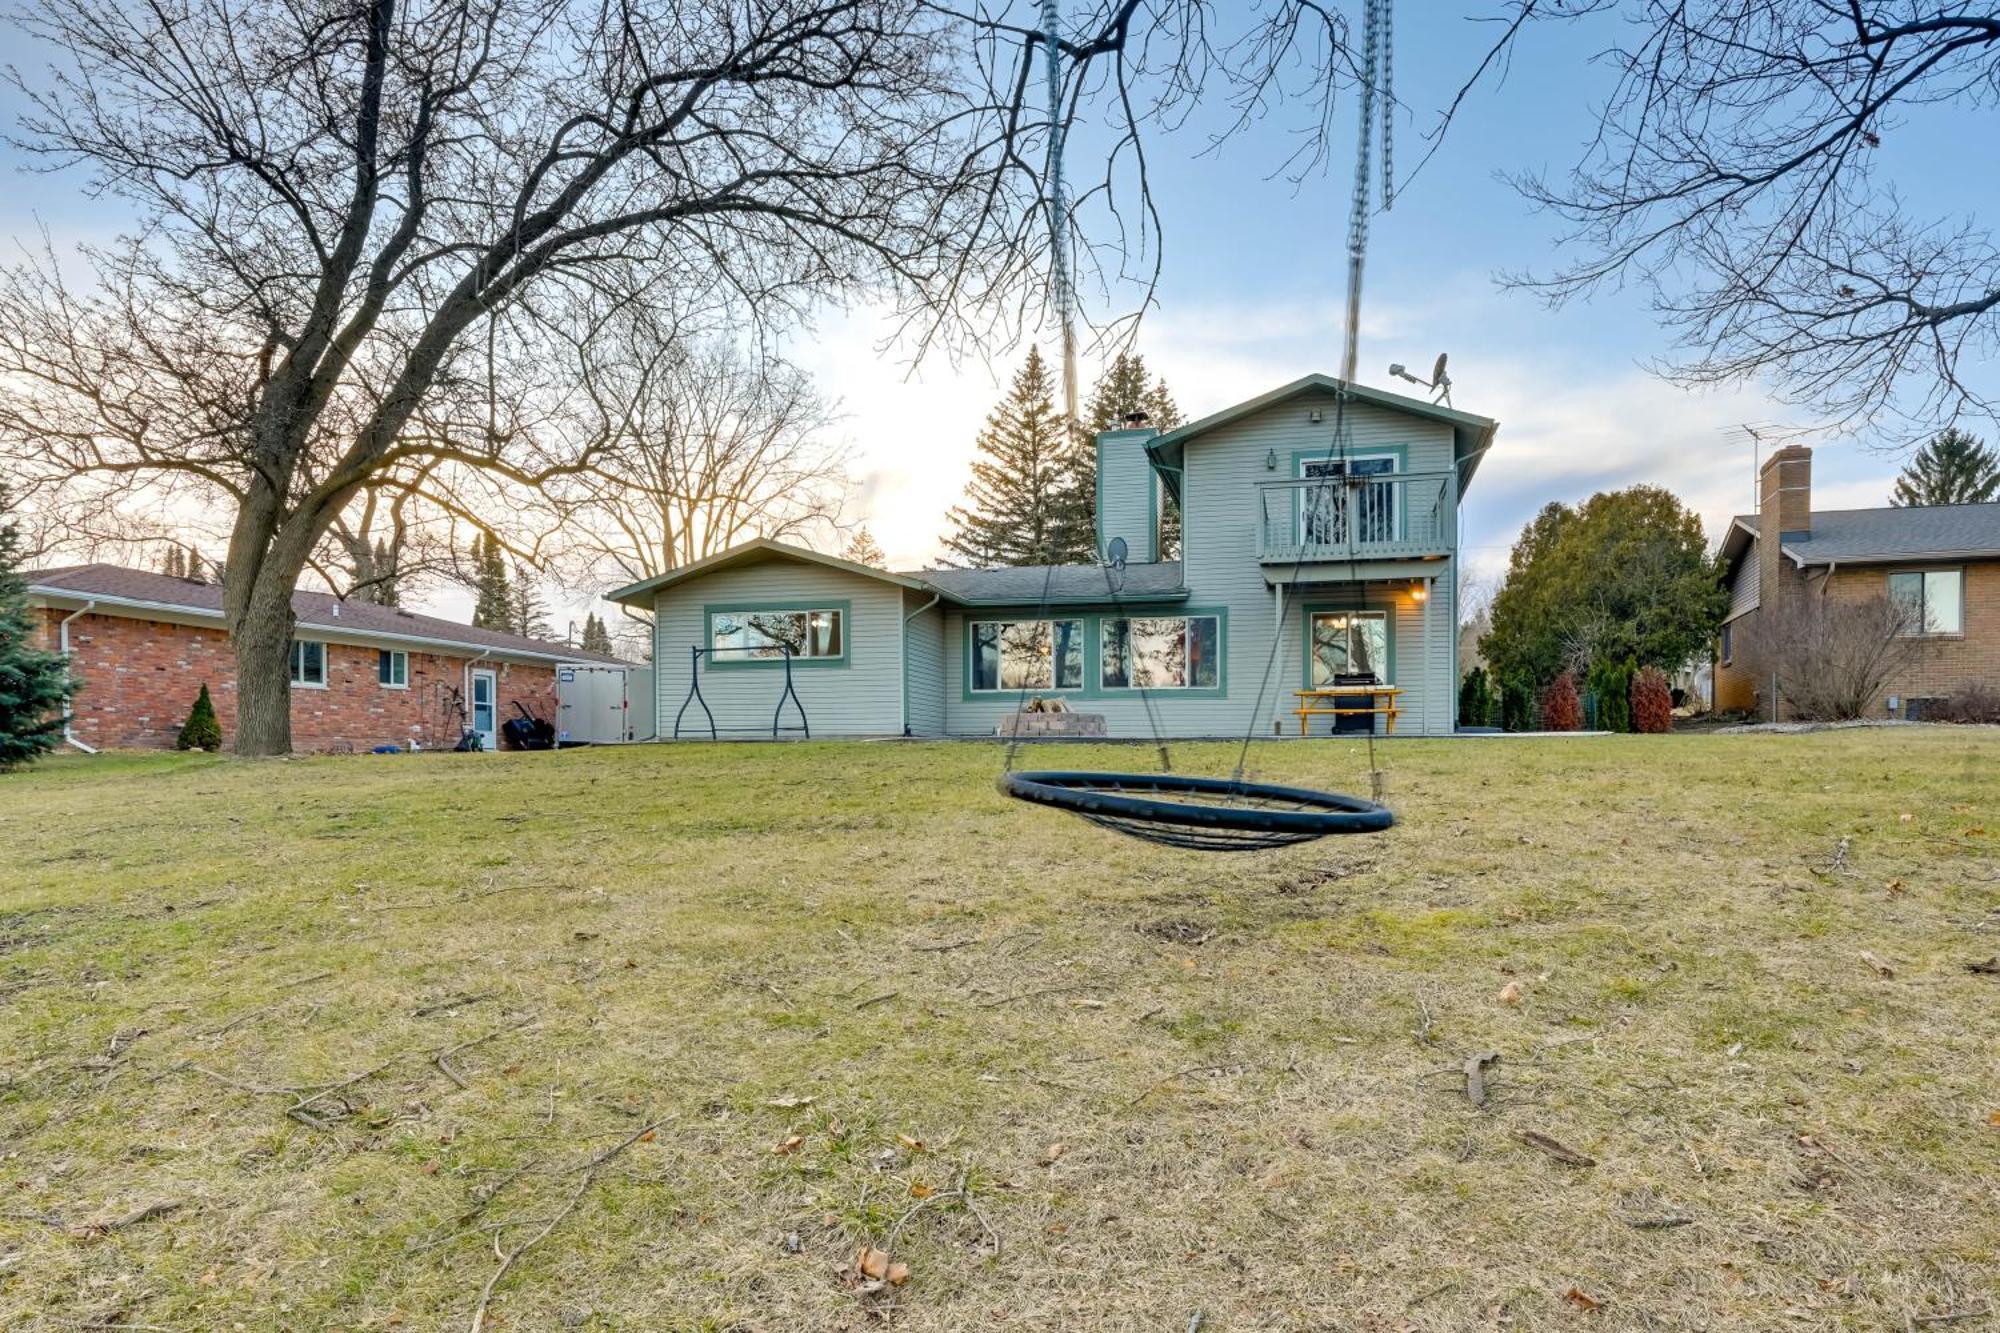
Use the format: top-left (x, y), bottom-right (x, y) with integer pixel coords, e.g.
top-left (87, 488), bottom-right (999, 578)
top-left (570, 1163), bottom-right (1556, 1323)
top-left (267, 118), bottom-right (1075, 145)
top-left (22, 564), bottom-right (618, 662)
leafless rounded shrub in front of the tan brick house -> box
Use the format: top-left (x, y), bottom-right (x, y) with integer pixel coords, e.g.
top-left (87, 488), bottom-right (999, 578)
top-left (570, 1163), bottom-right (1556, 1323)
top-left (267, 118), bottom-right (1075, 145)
top-left (1754, 586), bottom-right (1930, 723)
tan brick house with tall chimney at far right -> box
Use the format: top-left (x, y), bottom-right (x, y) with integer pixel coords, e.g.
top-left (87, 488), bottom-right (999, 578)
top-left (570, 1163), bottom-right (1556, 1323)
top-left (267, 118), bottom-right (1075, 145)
top-left (1716, 444), bottom-right (2000, 719)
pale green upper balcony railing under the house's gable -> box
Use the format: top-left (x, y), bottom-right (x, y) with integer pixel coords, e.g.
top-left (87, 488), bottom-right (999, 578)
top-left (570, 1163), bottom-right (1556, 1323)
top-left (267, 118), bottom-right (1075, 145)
top-left (1258, 472), bottom-right (1454, 560)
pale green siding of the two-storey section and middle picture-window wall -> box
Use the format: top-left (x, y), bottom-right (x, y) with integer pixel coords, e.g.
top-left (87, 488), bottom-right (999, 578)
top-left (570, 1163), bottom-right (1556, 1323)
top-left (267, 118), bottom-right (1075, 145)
top-left (944, 384), bottom-right (1458, 737)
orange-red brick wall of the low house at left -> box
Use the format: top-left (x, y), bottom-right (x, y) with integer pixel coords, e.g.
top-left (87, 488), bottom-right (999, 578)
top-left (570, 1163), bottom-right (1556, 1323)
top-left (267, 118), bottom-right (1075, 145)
top-left (44, 610), bottom-right (556, 751)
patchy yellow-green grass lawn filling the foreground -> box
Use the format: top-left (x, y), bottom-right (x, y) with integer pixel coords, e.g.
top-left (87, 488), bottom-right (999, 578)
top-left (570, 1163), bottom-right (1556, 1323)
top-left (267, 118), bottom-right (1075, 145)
top-left (0, 729), bottom-right (2000, 1333)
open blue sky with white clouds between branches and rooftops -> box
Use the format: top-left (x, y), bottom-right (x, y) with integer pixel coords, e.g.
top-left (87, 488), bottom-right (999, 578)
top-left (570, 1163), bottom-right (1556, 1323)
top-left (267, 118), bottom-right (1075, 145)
top-left (0, 9), bottom-right (1968, 608)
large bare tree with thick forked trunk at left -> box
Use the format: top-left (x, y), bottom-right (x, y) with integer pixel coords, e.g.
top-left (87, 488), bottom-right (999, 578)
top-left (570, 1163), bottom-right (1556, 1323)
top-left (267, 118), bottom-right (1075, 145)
top-left (0, 0), bottom-right (1408, 755)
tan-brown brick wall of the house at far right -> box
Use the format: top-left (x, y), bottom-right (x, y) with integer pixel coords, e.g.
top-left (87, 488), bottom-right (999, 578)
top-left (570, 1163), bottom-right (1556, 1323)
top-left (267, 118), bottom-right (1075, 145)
top-left (1716, 560), bottom-right (2000, 717)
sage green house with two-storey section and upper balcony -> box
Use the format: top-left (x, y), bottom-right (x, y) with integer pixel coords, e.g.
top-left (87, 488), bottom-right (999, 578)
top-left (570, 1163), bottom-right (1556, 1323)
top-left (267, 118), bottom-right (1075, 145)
top-left (610, 374), bottom-right (1496, 739)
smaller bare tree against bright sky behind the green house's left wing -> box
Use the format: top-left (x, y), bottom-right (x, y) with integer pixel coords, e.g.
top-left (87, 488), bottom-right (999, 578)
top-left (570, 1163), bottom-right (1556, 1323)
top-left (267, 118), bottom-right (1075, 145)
top-left (562, 332), bottom-right (846, 582)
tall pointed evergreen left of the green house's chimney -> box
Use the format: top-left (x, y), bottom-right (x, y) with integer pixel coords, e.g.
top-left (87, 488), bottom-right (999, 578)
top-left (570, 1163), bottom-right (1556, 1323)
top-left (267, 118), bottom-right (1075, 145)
top-left (940, 348), bottom-right (1074, 566)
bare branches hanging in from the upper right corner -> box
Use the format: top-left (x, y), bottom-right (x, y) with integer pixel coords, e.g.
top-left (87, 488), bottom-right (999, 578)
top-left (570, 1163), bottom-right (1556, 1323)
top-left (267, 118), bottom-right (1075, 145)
top-left (1488, 0), bottom-right (2000, 438)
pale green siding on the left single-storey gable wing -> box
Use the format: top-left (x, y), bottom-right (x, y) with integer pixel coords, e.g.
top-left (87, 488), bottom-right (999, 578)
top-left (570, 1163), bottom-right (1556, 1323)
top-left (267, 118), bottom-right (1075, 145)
top-left (654, 560), bottom-right (904, 739)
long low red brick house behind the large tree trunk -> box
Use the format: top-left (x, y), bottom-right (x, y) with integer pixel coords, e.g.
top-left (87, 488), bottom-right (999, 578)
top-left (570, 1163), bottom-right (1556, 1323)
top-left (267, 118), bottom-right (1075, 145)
top-left (24, 564), bottom-right (608, 751)
